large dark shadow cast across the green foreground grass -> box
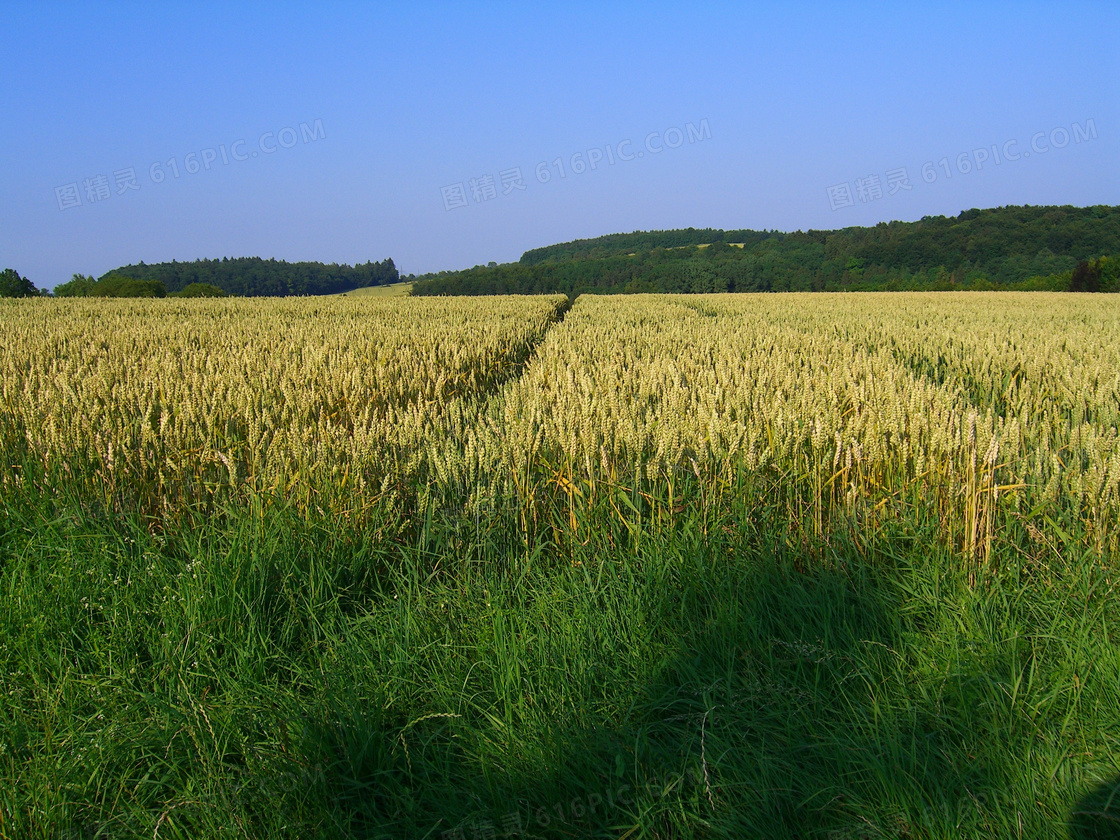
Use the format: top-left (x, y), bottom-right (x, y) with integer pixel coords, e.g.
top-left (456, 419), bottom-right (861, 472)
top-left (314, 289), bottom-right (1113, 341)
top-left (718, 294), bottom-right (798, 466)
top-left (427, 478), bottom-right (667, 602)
top-left (277, 535), bottom-right (1025, 840)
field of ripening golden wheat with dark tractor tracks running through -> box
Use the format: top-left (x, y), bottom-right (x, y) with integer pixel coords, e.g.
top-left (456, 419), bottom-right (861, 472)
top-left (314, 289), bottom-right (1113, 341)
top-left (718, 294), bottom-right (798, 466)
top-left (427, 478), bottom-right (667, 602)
top-left (0, 292), bottom-right (1120, 553)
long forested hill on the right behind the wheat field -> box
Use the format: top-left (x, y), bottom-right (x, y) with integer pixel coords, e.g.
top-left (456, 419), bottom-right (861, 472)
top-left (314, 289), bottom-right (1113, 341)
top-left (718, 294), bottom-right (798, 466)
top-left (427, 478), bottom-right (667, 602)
top-left (412, 206), bottom-right (1120, 296)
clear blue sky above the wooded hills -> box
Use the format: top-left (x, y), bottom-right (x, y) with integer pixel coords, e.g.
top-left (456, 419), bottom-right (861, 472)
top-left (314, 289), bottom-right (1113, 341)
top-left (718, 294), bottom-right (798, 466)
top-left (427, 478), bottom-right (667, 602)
top-left (0, 0), bottom-right (1120, 288)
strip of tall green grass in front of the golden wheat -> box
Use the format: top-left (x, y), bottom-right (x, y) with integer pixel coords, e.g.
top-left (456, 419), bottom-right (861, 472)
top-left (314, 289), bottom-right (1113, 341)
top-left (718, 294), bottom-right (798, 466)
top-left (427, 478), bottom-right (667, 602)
top-left (0, 486), bottom-right (1120, 839)
